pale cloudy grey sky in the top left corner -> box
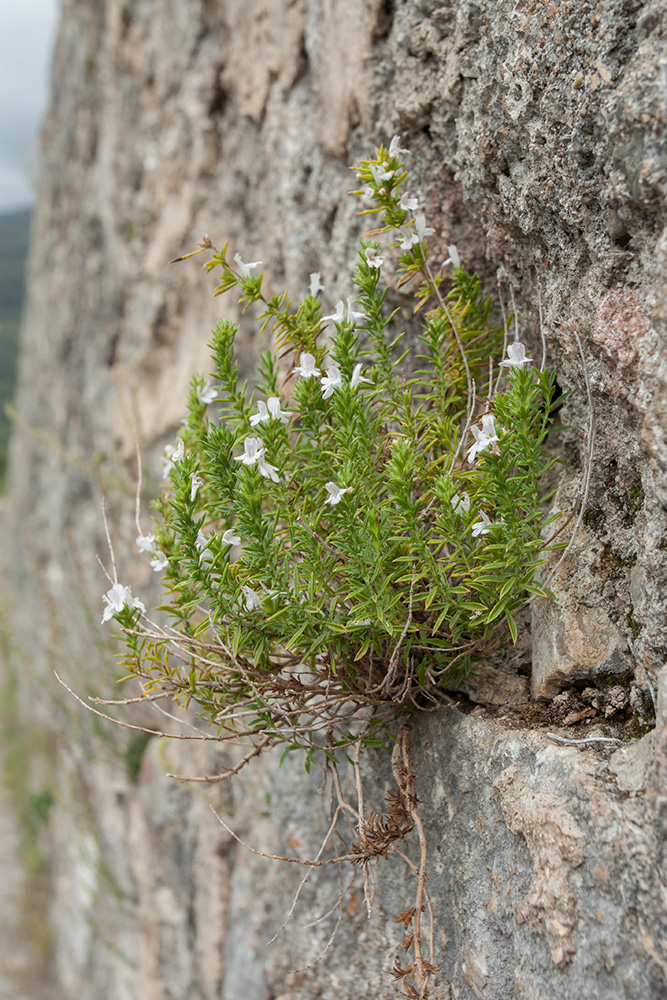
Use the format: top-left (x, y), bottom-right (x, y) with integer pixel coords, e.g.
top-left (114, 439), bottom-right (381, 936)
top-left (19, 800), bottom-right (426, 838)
top-left (0, 0), bottom-right (59, 212)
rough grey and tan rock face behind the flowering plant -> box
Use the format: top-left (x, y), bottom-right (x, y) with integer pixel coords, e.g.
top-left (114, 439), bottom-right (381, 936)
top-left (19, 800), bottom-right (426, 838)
top-left (3, 0), bottom-right (667, 1000)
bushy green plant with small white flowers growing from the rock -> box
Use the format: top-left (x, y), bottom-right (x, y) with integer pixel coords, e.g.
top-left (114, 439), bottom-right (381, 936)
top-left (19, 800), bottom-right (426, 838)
top-left (104, 137), bottom-right (555, 996)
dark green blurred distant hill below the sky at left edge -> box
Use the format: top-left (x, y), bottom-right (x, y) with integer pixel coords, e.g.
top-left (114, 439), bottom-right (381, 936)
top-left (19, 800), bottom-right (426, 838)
top-left (0, 208), bottom-right (30, 489)
